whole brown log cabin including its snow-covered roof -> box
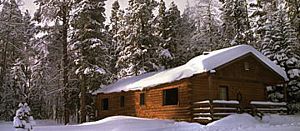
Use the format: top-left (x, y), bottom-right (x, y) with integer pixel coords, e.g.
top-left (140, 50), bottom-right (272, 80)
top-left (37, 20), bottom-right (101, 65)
top-left (93, 45), bottom-right (288, 121)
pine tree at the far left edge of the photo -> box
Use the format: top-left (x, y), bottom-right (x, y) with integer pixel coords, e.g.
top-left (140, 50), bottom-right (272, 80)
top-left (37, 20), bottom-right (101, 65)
top-left (0, 0), bottom-right (25, 120)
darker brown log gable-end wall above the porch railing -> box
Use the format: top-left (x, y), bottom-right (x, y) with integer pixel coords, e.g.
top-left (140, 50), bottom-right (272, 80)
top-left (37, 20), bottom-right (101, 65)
top-left (190, 54), bottom-right (284, 108)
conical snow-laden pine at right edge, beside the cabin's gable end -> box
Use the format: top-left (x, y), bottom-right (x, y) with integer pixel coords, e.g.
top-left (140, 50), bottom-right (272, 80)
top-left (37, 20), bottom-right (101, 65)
top-left (261, 8), bottom-right (300, 102)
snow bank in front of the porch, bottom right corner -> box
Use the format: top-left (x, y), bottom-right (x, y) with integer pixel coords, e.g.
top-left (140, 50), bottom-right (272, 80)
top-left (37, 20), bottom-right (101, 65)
top-left (204, 114), bottom-right (300, 131)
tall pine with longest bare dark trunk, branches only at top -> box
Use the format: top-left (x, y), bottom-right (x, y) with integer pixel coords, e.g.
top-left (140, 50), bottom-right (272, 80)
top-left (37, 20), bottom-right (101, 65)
top-left (35, 0), bottom-right (74, 124)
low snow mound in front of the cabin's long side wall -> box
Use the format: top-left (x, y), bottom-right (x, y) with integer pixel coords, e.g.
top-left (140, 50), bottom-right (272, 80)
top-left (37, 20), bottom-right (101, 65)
top-left (72, 116), bottom-right (203, 131)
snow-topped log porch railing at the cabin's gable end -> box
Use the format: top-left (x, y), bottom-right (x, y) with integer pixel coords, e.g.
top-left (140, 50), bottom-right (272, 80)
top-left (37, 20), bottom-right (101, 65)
top-left (191, 100), bottom-right (287, 124)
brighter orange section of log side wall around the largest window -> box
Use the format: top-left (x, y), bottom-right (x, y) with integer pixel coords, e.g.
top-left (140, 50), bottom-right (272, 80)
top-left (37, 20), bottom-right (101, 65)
top-left (135, 80), bottom-right (191, 120)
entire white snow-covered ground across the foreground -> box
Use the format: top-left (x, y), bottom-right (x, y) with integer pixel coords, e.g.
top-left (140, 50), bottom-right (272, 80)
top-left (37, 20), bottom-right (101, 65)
top-left (0, 114), bottom-right (300, 131)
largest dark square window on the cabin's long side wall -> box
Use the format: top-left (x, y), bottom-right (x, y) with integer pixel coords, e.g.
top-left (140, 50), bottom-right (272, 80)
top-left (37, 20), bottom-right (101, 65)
top-left (163, 88), bottom-right (178, 105)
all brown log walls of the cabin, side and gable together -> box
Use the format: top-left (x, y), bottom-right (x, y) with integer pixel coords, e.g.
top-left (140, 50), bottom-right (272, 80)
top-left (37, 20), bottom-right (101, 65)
top-left (96, 54), bottom-right (284, 121)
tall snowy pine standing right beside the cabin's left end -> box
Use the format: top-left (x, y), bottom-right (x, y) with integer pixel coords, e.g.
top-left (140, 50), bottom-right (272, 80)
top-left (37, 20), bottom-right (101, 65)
top-left (71, 0), bottom-right (109, 122)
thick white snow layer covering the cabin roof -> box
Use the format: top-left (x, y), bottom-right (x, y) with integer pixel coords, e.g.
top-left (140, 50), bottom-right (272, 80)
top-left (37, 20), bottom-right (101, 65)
top-left (93, 45), bottom-right (288, 95)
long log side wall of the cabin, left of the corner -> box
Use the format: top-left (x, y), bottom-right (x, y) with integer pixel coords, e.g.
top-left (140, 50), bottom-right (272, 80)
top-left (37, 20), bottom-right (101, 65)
top-left (96, 80), bottom-right (191, 120)
